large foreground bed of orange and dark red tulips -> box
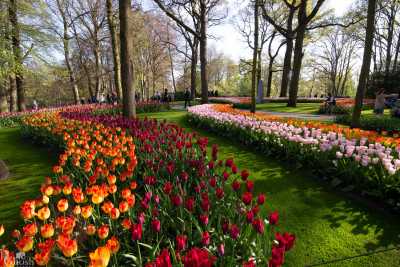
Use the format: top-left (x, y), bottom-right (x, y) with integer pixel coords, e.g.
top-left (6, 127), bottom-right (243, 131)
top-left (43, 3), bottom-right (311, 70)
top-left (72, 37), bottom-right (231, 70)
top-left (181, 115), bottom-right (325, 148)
top-left (0, 107), bottom-right (295, 267)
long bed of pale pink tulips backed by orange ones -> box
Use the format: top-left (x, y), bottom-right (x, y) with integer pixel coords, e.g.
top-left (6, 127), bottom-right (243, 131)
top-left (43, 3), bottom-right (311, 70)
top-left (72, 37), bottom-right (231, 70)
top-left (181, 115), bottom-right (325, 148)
top-left (188, 105), bottom-right (400, 208)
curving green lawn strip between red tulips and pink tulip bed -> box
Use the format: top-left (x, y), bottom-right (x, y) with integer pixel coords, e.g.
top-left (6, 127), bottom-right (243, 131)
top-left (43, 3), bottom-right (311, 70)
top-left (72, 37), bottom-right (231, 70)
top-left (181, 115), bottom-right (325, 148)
top-left (141, 111), bottom-right (400, 267)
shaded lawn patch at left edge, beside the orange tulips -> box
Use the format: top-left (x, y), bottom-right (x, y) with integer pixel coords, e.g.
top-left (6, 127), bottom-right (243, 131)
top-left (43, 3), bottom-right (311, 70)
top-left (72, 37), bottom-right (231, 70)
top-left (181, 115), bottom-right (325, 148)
top-left (0, 128), bottom-right (57, 243)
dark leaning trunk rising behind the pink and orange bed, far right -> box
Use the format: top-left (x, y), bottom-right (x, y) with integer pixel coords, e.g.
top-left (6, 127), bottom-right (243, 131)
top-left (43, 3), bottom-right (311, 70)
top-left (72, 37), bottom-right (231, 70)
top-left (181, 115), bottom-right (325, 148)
top-left (351, 0), bottom-right (376, 127)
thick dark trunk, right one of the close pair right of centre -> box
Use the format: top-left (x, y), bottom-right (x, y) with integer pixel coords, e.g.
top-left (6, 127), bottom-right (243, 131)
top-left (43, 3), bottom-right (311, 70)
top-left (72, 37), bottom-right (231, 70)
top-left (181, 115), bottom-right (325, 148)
top-left (288, 1), bottom-right (307, 107)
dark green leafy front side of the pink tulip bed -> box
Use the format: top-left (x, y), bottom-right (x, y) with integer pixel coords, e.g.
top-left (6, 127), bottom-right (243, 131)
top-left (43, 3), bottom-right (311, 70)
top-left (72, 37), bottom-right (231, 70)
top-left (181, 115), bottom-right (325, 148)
top-left (186, 106), bottom-right (400, 213)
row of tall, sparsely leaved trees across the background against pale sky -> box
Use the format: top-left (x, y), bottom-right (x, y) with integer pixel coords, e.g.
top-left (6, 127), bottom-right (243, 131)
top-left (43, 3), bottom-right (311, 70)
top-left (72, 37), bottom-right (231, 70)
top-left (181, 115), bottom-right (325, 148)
top-left (0, 0), bottom-right (394, 126)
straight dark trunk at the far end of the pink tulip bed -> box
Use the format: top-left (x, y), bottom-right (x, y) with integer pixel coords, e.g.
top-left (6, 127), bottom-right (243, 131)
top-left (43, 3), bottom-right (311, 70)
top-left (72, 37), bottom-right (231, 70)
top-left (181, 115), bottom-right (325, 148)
top-left (200, 0), bottom-right (208, 104)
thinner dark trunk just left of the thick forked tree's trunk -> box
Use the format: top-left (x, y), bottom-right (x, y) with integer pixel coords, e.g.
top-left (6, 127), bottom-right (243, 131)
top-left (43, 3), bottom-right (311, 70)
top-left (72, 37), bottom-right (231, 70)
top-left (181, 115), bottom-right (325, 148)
top-left (279, 10), bottom-right (295, 97)
